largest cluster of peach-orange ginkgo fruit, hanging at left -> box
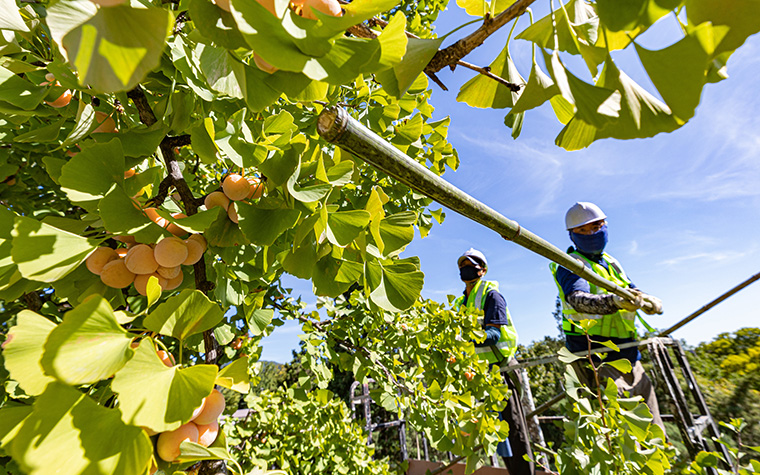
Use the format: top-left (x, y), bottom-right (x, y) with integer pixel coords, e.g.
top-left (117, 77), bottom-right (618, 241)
top-left (85, 234), bottom-right (206, 295)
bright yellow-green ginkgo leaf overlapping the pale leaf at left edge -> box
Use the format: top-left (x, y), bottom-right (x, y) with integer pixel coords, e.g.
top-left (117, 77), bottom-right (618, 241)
top-left (42, 294), bottom-right (134, 385)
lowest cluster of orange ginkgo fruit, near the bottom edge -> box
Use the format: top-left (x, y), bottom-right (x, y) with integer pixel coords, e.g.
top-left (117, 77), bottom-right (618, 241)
top-left (146, 350), bottom-right (225, 473)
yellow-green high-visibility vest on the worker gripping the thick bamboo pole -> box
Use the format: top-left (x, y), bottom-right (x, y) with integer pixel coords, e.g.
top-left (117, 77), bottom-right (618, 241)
top-left (549, 251), bottom-right (637, 338)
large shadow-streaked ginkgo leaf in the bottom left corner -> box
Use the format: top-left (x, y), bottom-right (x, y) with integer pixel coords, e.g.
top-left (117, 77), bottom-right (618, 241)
top-left (9, 382), bottom-right (153, 475)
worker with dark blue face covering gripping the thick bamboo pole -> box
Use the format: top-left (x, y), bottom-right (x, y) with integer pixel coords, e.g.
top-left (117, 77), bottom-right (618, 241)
top-left (550, 202), bottom-right (664, 430)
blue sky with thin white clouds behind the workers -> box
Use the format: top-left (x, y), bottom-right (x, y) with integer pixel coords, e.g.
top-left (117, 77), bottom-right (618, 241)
top-left (262, 0), bottom-right (760, 362)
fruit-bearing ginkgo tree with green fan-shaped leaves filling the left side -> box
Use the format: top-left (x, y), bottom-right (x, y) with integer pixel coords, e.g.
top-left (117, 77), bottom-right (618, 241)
top-left (0, 0), bottom-right (760, 474)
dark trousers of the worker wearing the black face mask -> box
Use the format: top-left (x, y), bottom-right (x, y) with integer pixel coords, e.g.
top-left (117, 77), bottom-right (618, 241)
top-left (501, 366), bottom-right (536, 475)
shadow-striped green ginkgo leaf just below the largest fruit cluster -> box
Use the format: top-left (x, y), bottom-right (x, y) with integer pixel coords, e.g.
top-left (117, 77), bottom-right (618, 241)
top-left (144, 289), bottom-right (224, 341)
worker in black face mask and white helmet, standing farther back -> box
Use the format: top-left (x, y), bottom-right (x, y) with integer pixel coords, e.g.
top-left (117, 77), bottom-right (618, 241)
top-left (454, 249), bottom-right (535, 475)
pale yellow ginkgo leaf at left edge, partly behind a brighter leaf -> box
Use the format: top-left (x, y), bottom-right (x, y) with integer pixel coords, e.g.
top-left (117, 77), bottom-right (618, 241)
top-left (3, 310), bottom-right (56, 396)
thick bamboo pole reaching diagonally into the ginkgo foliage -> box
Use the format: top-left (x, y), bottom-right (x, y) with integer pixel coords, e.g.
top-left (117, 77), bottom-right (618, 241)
top-left (317, 107), bottom-right (652, 312)
